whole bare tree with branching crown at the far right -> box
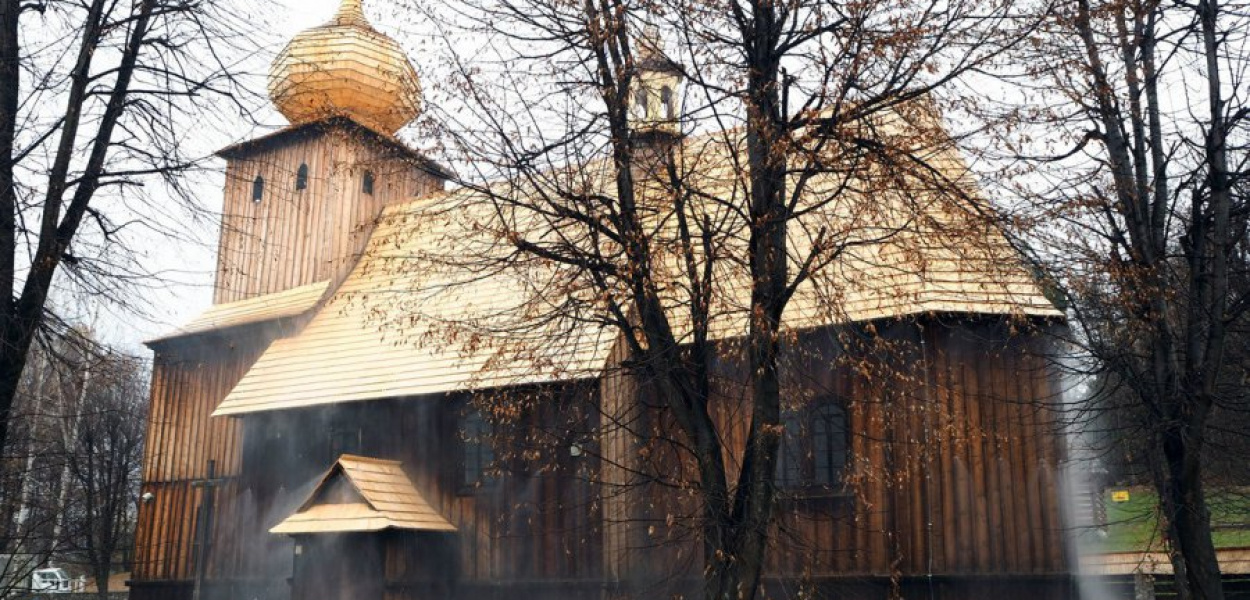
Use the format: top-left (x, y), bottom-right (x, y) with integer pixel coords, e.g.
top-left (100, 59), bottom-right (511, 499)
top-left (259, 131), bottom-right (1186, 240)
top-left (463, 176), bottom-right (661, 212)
top-left (983, 0), bottom-right (1250, 600)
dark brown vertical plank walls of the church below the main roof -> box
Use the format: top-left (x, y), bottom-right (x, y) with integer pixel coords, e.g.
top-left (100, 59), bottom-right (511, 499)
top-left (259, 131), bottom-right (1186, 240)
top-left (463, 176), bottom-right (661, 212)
top-left (135, 319), bottom-right (1066, 600)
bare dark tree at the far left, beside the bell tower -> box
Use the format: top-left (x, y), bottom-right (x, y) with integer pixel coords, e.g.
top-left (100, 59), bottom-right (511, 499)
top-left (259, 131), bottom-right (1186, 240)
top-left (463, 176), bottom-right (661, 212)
top-left (0, 0), bottom-right (256, 465)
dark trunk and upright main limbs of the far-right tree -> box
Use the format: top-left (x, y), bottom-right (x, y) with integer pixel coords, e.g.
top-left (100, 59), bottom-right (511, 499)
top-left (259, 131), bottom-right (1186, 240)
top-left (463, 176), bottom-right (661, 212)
top-left (1074, 0), bottom-right (1231, 600)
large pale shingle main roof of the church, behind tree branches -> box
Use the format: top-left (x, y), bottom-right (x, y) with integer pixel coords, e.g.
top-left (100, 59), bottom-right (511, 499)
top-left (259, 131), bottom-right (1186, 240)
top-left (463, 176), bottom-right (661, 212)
top-left (214, 107), bottom-right (1061, 415)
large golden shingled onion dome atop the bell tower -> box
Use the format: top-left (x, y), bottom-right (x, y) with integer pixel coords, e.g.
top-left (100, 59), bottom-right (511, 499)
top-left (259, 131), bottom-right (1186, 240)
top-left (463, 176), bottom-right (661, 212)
top-left (269, 0), bottom-right (421, 135)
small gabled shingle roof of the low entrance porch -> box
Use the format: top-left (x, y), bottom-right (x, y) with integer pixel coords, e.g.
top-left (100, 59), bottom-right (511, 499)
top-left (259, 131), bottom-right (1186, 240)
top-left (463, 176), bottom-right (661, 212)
top-left (269, 454), bottom-right (456, 535)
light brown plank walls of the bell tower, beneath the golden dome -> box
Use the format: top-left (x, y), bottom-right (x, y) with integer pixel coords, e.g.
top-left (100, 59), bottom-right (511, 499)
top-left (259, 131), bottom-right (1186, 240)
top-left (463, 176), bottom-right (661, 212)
top-left (214, 128), bottom-right (443, 304)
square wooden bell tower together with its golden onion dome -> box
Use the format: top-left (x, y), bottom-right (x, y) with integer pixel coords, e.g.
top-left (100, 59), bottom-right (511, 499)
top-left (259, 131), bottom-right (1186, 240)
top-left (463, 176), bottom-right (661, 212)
top-left (205, 0), bottom-right (446, 304)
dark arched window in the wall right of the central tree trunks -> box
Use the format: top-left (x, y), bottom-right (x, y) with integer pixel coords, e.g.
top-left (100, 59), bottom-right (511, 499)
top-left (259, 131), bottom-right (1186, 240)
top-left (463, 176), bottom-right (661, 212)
top-left (776, 399), bottom-right (850, 493)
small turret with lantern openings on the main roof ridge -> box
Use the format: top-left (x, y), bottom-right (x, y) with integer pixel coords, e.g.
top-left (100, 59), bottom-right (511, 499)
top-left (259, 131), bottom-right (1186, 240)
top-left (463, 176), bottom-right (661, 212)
top-left (630, 28), bottom-right (685, 135)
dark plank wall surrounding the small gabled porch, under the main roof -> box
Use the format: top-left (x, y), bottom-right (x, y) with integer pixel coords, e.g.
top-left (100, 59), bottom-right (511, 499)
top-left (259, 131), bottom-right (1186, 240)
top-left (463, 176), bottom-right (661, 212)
top-left (221, 387), bottom-right (603, 598)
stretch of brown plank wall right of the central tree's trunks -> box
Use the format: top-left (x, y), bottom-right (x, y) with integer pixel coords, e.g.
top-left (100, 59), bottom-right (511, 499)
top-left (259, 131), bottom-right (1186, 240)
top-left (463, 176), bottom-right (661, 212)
top-left (770, 320), bottom-right (1068, 576)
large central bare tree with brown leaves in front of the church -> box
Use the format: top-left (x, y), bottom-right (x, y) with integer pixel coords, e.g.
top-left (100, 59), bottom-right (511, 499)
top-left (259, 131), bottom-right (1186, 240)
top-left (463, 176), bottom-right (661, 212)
top-left (393, 0), bottom-right (1033, 600)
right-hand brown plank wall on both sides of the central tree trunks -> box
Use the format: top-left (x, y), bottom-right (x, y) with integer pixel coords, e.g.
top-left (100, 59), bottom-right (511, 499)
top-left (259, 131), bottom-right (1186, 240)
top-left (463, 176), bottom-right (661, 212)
top-left (603, 318), bottom-right (1068, 588)
